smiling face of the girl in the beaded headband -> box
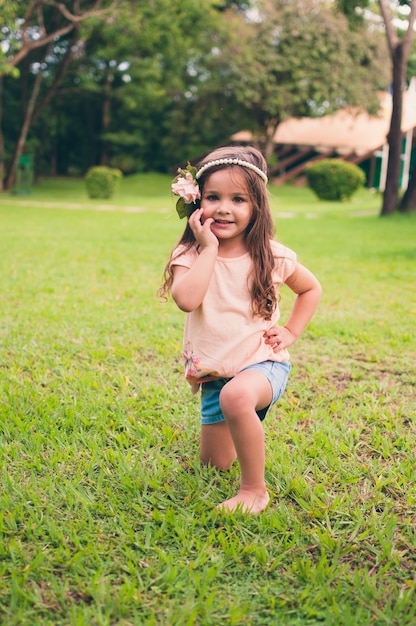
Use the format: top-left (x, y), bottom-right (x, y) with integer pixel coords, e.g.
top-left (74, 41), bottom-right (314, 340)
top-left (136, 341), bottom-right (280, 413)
top-left (201, 168), bottom-right (253, 250)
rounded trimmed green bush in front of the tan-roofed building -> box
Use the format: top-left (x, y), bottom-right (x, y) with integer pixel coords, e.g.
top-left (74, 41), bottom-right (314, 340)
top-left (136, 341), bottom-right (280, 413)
top-left (305, 159), bottom-right (365, 200)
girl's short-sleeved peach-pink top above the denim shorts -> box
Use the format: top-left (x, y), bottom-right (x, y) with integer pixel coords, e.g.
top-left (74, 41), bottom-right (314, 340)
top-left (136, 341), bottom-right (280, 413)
top-left (171, 241), bottom-right (296, 392)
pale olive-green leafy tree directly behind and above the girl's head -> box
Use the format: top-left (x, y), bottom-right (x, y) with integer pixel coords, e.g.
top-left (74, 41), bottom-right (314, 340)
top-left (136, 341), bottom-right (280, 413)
top-left (211, 0), bottom-right (386, 157)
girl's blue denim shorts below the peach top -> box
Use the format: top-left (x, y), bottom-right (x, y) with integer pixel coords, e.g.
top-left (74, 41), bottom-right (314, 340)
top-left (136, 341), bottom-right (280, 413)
top-left (201, 361), bottom-right (291, 424)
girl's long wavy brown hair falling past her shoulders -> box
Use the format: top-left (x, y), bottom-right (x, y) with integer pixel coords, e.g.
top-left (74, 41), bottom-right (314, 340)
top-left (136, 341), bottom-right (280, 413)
top-left (159, 146), bottom-right (277, 320)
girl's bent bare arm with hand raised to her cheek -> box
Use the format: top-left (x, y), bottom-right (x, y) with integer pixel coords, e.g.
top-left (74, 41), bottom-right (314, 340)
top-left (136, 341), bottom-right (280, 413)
top-left (171, 209), bottom-right (219, 313)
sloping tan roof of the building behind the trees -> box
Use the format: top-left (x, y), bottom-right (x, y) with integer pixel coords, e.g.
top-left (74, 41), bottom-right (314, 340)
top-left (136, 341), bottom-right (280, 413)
top-left (232, 78), bottom-right (416, 155)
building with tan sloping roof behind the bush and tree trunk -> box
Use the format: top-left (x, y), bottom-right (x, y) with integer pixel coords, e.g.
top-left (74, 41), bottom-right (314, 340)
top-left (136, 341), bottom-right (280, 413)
top-left (232, 78), bottom-right (416, 191)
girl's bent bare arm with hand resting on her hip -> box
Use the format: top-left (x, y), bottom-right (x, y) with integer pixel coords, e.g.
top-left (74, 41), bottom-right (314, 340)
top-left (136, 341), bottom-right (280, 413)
top-left (264, 263), bottom-right (322, 352)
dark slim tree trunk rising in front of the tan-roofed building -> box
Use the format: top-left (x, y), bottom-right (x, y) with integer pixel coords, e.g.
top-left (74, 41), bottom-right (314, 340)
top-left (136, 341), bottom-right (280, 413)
top-left (381, 43), bottom-right (404, 215)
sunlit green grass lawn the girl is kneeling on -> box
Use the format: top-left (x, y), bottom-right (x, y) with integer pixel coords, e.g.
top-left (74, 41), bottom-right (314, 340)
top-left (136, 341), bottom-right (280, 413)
top-left (0, 174), bottom-right (416, 626)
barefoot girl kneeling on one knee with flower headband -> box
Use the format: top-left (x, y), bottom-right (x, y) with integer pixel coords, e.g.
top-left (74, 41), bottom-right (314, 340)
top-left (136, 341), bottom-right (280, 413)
top-left (161, 146), bottom-right (321, 514)
